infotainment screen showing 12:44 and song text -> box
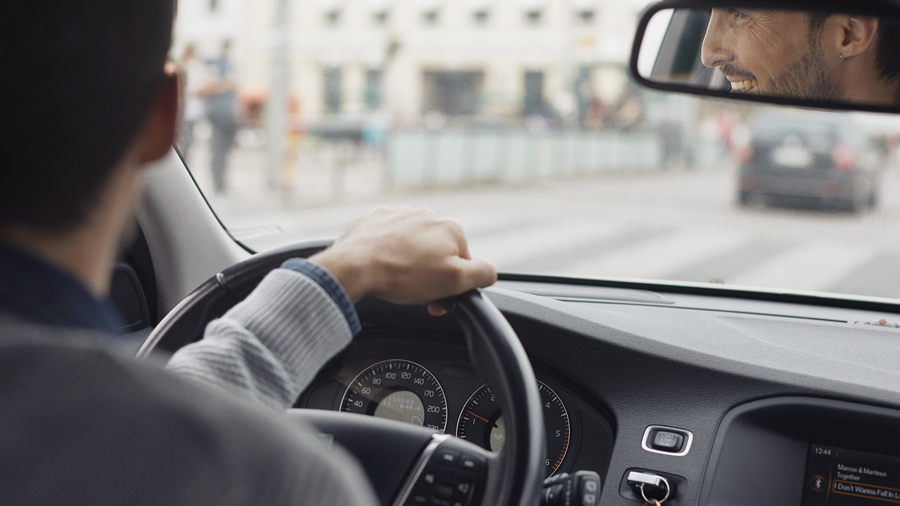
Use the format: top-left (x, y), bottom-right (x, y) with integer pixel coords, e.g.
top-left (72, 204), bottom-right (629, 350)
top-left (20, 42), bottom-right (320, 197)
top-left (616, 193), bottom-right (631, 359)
top-left (803, 444), bottom-right (900, 506)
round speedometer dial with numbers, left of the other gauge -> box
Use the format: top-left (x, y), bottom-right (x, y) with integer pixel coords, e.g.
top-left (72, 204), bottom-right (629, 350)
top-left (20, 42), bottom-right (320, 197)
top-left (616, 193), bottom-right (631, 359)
top-left (341, 359), bottom-right (447, 432)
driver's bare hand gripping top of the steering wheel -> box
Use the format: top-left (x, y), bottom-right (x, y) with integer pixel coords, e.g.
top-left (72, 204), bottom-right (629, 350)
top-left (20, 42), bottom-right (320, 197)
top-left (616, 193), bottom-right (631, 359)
top-left (309, 207), bottom-right (497, 315)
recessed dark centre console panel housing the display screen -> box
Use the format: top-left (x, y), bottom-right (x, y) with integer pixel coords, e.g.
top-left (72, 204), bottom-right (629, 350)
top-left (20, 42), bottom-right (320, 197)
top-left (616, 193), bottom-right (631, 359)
top-left (700, 397), bottom-right (900, 506)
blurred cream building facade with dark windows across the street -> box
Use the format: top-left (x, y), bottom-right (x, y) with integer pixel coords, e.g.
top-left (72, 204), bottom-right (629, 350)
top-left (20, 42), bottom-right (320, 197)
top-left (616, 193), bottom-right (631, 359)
top-left (173, 0), bottom-right (645, 123)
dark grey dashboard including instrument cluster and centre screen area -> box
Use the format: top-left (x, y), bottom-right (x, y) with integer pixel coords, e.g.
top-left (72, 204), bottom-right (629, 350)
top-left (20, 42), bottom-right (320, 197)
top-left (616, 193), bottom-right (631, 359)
top-left (297, 280), bottom-right (900, 506)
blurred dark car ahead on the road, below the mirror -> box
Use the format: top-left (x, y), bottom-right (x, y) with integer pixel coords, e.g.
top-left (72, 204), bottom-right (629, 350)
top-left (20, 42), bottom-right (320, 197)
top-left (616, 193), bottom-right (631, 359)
top-left (738, 111), bottom-right (882, 211)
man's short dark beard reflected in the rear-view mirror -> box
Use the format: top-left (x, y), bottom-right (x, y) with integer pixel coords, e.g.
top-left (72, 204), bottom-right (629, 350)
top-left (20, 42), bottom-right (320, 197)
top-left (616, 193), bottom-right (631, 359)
top-left (769, 44), bottom-right (846, 102)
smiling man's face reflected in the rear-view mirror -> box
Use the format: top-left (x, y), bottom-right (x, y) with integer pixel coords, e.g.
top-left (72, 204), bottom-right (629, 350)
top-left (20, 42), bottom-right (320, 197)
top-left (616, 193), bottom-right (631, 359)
top-left (701, 8), bottom-right (898, 104)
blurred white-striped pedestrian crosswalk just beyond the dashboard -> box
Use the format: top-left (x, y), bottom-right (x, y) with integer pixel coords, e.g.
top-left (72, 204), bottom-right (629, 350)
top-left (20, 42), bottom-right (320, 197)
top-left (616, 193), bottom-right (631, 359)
top-left (458, 220), bottom-right (900, 298)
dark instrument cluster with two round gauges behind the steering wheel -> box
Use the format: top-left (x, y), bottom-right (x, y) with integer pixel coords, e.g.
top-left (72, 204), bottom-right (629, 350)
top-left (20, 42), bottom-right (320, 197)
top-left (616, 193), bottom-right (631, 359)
top-left (297, 330), bottom-right (613, 477)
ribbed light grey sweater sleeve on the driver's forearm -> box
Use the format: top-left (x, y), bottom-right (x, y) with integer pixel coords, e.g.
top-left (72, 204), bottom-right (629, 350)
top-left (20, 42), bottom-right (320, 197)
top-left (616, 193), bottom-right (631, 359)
top-left (167, 269), bottom-right (352, 410)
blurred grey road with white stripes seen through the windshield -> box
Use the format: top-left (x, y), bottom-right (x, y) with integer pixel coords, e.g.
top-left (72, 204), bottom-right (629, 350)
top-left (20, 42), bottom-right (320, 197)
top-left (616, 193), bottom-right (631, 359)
top-left (186, 140), bottom-right (900, 298)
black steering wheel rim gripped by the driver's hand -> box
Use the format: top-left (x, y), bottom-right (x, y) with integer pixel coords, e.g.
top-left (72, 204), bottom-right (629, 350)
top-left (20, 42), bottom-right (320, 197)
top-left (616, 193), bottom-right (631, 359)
top-left (136, 240), bottom-right (546, 506)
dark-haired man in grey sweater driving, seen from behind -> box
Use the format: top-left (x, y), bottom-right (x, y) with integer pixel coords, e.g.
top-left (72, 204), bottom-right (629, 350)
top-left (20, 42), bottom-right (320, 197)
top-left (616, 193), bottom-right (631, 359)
top-left (0, 0), bottom-right (496, 505)
